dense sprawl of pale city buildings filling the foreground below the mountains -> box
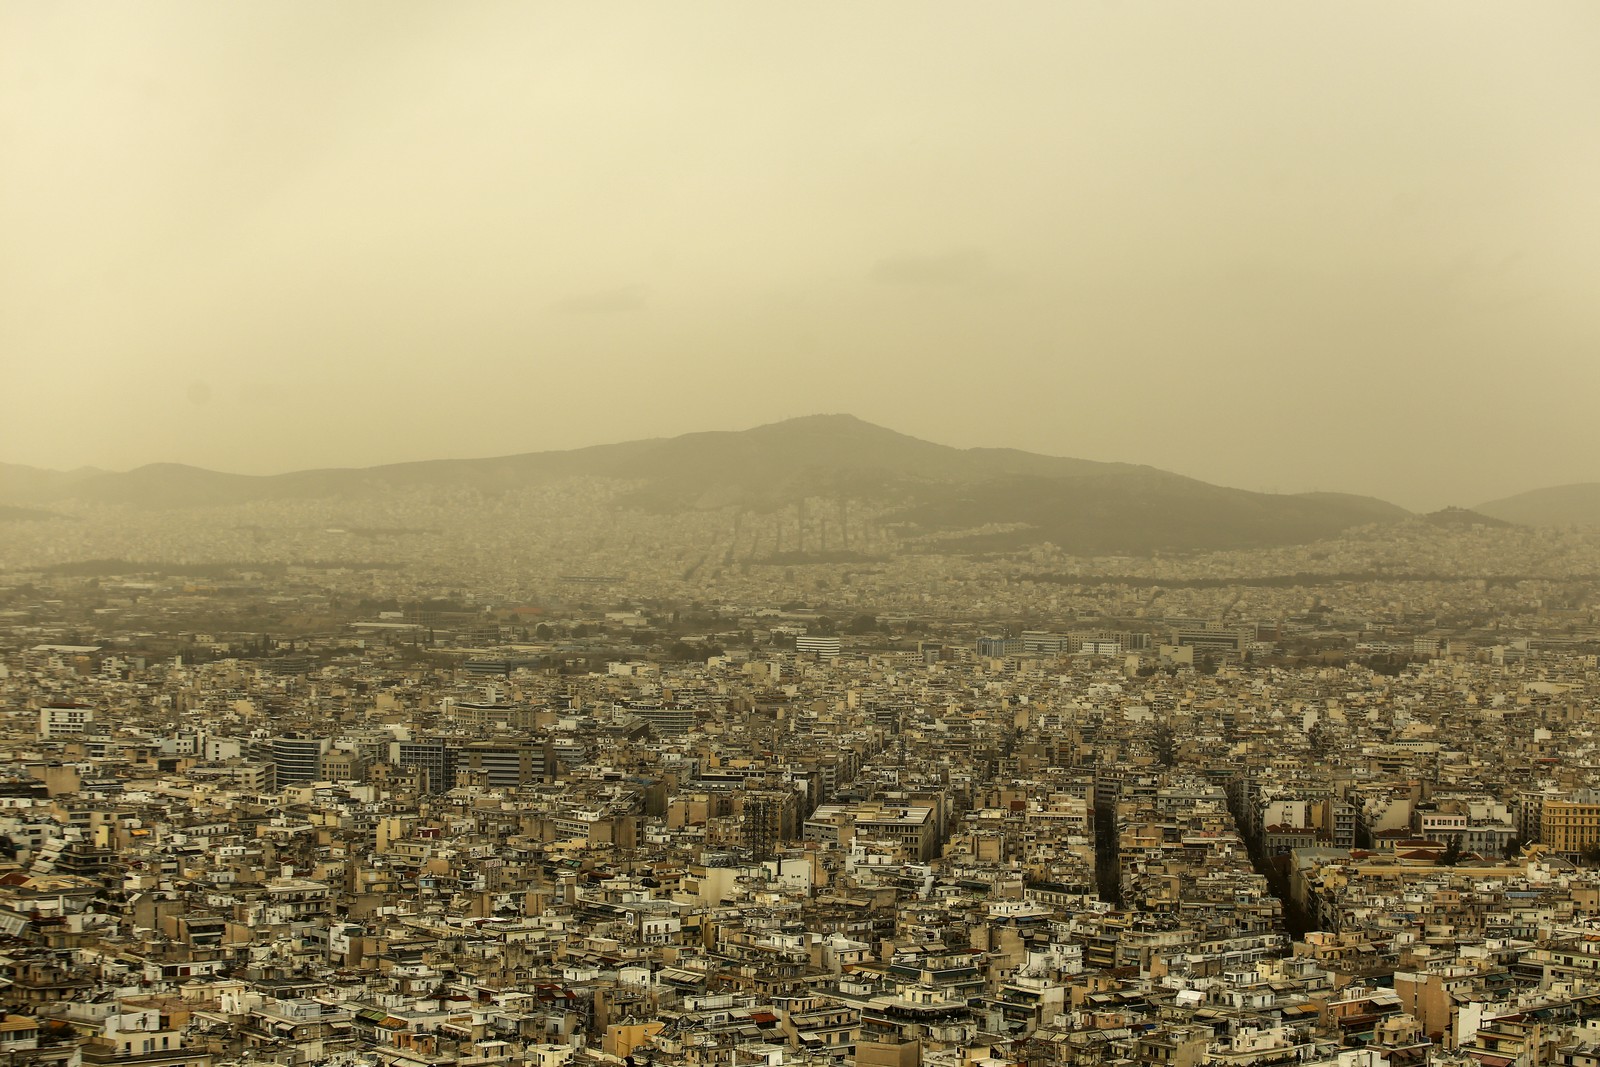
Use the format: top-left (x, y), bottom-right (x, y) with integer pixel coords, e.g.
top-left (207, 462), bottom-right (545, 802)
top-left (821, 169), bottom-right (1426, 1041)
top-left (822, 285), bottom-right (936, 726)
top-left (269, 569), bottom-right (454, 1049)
top-left (0, 492), bottom-right (1600, 1067)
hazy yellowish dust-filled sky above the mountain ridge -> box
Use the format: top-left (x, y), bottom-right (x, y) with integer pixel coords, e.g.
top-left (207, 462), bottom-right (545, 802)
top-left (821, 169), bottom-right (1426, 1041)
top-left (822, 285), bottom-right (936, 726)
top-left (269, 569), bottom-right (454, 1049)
top-left (0, 0), bottom-right (1600, 507)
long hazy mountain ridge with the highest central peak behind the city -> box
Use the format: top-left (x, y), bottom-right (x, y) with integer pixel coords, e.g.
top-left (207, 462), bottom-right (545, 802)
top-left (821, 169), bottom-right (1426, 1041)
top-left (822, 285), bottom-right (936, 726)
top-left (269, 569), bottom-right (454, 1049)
top-left (0, 414), bottom-right (1410, 553)
